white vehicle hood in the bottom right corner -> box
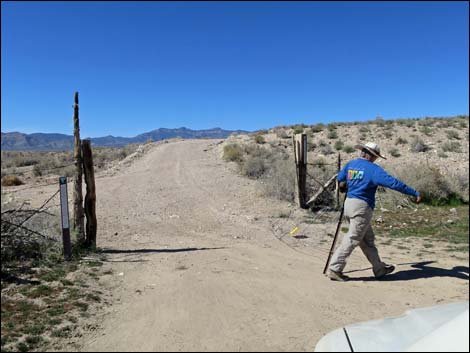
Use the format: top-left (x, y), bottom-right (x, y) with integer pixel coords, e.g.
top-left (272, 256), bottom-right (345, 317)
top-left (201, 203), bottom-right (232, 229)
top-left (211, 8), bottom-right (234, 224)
top-left (315, 301), bottom-right (469, 352)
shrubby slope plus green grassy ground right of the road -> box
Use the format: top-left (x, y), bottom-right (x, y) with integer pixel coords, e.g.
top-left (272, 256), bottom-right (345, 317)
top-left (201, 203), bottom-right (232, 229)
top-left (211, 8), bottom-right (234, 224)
top-left (223, 115), bottom-right (469, 258)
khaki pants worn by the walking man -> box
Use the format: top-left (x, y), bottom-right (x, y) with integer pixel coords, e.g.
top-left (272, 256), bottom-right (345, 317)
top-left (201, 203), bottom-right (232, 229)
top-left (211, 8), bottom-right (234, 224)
top-left (329, 198), bottom-right (385, 276)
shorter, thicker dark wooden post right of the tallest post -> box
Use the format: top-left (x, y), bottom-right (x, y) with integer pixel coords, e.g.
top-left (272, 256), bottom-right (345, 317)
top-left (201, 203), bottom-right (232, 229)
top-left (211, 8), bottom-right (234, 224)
top-left (82, 140), bottom-right (97, 248)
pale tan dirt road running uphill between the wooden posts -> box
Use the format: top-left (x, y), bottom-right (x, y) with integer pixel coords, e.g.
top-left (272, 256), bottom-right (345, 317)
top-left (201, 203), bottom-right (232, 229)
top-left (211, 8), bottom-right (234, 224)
top-left (57, 140), bottom-right (468, 351)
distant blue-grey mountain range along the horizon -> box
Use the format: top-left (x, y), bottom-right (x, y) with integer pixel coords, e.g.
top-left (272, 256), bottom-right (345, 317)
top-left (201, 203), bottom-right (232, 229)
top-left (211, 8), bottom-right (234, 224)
top-left (1, 127), bottom-right (247, 151)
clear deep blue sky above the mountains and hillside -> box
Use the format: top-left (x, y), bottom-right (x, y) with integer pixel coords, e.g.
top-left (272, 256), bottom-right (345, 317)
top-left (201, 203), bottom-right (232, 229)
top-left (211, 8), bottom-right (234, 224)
top-left (1, 1), bottom-right (469, 137)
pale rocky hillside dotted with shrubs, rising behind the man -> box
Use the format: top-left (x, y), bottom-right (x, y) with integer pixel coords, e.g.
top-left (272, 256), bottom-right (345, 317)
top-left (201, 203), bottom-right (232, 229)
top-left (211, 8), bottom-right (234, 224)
top-left (224, 115), bottom-right (469, 202)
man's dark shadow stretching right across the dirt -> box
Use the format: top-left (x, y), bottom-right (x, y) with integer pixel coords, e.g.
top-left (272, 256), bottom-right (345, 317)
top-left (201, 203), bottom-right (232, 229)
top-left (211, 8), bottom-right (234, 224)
top-left (345, 261), bottom-right (469, 282)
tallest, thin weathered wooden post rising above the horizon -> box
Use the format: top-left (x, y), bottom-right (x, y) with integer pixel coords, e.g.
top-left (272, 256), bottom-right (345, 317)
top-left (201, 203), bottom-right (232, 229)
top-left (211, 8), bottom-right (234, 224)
top-left (73, 92), bottom-right (85, 243)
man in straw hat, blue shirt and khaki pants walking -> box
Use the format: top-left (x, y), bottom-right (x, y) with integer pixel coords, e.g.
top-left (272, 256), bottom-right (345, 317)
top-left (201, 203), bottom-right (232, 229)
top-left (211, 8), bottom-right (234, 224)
top-left (328, 142), bottom-right (421, 281)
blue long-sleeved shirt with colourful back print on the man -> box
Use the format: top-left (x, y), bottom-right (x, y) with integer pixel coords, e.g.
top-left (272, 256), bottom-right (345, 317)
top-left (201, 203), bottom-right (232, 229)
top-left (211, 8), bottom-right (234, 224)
top-left (337, 158), bottom-right (419, 209)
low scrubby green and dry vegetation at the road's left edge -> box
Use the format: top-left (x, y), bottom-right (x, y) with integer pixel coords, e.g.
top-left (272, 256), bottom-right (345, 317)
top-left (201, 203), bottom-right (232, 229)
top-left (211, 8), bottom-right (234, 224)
top-left (1, 204), bottom-right (110, 352)
